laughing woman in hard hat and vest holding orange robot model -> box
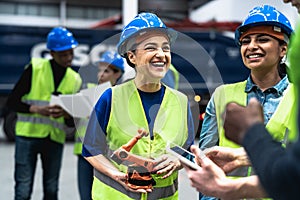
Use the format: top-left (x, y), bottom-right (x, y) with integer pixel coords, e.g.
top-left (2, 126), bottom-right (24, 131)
top-left (82, 13), bottom-right (194, 200)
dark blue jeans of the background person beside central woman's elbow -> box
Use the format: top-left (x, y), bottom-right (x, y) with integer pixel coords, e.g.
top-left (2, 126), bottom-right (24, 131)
top-left (77, 155), bottom-right (94, 200)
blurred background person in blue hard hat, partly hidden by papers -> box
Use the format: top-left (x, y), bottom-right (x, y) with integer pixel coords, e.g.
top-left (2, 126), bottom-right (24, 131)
top-left (74, 50), bottom-right (124, 200)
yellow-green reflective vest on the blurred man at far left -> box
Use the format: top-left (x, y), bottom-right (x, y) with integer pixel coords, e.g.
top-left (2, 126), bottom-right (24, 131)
top-left (16, 58), bottom-right (81, 143)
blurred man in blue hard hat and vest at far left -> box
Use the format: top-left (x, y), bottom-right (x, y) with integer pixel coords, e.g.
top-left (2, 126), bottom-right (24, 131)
top-left (8, 27), bottom-right (81, 199)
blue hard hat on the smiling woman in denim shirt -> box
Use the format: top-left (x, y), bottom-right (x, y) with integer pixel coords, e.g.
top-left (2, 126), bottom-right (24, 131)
top-left (235, 5), bottom-right (293, 46)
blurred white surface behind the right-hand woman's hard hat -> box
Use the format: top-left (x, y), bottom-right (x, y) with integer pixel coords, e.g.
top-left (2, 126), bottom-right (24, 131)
top-left (190, 0), bottom-right (298, 26)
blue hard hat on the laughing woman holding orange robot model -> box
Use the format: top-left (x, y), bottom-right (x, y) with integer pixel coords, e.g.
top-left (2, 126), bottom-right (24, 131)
top-left (117, 13), bottom-right (177, 57)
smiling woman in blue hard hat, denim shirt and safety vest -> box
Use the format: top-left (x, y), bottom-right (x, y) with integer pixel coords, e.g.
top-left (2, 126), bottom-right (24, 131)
top-left (199, 5), bottom-right (295, 199)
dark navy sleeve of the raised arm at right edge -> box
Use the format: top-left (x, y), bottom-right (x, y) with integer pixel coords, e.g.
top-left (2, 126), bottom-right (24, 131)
top-left (243, 125), bottom-right (300, 199)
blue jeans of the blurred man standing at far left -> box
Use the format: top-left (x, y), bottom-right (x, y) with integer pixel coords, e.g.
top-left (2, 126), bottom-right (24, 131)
top-left (15, 136), bottom-right (63, 200)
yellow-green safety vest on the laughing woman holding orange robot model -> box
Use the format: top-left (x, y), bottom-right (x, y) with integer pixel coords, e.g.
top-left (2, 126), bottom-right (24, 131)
top-left (93, 81), bottom-right (188, 199)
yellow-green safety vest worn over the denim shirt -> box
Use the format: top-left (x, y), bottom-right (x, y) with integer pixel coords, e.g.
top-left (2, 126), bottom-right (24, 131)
top-left (214, 81), bottom-right (296, 200)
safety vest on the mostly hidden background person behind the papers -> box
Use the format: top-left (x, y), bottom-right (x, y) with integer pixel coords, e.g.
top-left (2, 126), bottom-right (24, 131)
top-left (73, 83), bottom-right (97, 155)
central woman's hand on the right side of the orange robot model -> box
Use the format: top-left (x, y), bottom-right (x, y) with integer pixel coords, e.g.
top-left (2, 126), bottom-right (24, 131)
top-left (153, 155), bottom-right (182, 178)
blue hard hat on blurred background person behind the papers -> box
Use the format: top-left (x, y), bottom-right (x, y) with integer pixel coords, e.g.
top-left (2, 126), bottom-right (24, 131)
top-left (99, 51), bottom-right (124, 72)
